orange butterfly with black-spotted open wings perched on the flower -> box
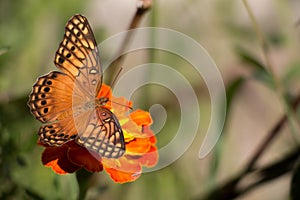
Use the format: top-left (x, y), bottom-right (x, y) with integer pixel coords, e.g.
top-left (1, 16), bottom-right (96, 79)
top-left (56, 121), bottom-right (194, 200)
top-left (28, 14), bottom-right (125, 158)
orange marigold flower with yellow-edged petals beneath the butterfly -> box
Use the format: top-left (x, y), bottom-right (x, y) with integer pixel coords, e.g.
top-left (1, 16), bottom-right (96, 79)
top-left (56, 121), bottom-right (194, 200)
top-left (38, 85), bottom-right (158, 183)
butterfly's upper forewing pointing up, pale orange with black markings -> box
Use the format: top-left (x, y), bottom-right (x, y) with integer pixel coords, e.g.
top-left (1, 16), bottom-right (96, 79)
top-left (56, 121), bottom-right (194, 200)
top-left (54, 15), bottom-right (102, 98)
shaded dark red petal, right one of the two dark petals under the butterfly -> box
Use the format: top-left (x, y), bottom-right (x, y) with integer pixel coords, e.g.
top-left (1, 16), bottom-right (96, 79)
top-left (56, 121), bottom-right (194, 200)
top-left (68, 145), bottom-right (103, 172)
